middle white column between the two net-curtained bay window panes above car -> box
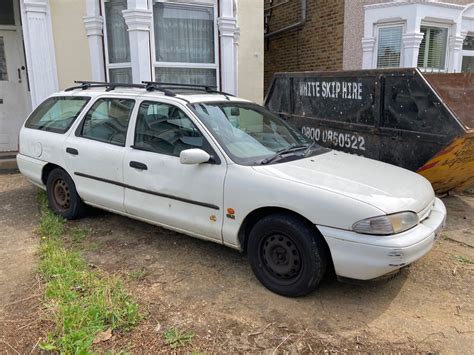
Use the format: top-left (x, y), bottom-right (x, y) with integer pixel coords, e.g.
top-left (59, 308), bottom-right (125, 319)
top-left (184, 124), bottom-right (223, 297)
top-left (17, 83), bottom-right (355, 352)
top-left (123, 0), bottom-right (152, 83)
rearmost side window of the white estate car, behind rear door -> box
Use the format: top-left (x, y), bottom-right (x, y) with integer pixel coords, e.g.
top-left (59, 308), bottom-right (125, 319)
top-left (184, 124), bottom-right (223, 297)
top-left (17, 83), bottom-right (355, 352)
top-left (25, 96), bottom-right (90, 133)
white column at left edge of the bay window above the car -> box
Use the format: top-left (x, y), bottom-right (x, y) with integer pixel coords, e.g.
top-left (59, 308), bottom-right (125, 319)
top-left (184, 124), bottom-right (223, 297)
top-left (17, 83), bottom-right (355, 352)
top-left (82, 0), bottom-right (105, 81)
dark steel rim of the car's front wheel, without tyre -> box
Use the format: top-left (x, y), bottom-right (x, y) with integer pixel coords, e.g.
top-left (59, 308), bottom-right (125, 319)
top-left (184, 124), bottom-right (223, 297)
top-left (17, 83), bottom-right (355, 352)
top-left (259, 234), bottom-right (303, 284)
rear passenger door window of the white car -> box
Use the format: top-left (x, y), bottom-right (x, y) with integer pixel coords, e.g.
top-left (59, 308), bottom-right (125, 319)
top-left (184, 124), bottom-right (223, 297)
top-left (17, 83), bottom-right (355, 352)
top-left (78, 98), bottom-right (135, 146)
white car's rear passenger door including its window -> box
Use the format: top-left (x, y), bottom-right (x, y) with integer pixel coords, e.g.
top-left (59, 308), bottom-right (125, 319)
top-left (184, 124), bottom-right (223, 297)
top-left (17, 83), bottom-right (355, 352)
top-left (65, 97), bottom-right (135, 212)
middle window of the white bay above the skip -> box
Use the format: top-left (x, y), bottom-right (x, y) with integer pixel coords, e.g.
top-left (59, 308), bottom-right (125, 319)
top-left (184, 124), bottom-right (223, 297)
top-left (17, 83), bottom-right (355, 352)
top-left (418, 26), bottom-right (448, 71)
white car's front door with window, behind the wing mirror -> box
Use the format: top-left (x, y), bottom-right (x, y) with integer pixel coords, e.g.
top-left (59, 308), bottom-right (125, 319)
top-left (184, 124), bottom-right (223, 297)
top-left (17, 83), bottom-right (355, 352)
top-left (123, 101), bottom-right (227, 241)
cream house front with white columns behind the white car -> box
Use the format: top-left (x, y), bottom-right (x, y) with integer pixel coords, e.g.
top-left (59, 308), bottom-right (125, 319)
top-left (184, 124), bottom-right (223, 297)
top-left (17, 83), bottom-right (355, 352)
top-left (0, 0), bottom-right (264, 152)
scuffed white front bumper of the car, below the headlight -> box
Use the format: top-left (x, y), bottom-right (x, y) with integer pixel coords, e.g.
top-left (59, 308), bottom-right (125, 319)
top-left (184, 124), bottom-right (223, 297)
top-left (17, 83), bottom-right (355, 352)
top-left (317, 198), bottom-right (446, 280)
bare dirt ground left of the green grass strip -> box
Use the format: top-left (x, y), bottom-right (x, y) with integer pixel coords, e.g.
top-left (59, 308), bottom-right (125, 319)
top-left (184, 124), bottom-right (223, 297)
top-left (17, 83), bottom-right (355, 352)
top-left (0, 174), bottom-right (46, 354)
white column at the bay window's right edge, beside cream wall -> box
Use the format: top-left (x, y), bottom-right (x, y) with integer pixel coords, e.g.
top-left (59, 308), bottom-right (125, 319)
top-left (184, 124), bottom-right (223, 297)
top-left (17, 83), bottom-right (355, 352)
top-left (217, 0), bottom-right (239, 95)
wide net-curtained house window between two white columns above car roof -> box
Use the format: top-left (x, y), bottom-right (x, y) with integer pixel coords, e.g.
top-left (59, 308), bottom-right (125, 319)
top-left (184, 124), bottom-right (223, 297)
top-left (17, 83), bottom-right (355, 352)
top-left (153, 1), bottom-right (218, 86)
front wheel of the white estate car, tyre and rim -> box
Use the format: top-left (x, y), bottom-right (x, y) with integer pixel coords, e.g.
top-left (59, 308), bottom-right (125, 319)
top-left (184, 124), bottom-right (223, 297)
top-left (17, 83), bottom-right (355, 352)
top-left (247, 214), bottom-right (328, 297)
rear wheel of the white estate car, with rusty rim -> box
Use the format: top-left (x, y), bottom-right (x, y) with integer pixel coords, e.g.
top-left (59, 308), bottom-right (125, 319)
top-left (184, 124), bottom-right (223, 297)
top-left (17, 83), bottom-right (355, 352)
top-left (46, 168), bottom-right (86, 219)
